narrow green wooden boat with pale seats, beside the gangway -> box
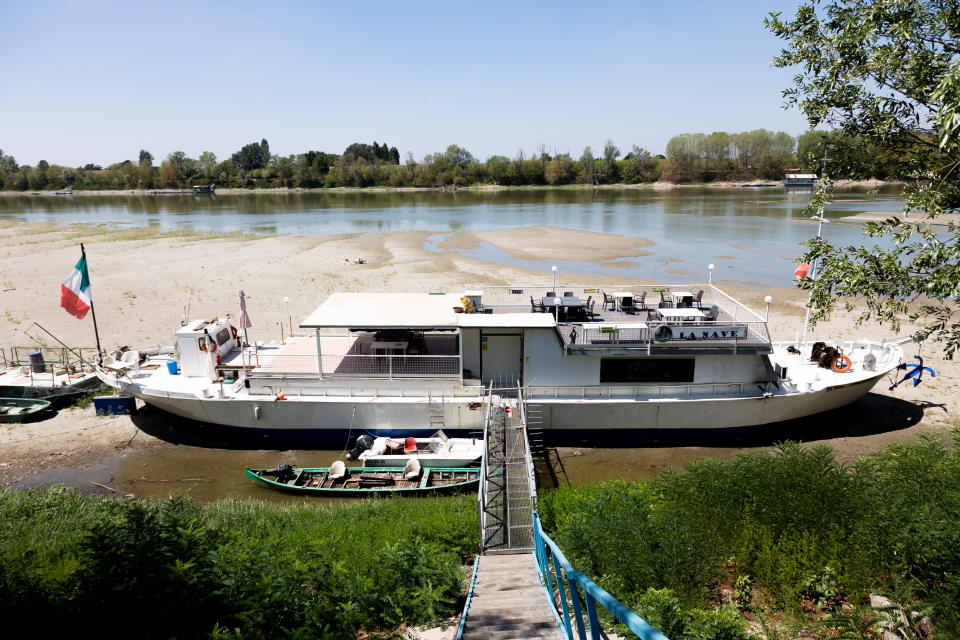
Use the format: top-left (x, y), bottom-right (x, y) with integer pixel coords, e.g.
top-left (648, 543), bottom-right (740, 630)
top-left (246, 462), bottom-right (480, 498)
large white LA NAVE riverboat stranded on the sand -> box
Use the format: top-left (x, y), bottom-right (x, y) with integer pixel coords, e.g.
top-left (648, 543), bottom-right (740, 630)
top-left (99, 284), bottom-right (902, 446)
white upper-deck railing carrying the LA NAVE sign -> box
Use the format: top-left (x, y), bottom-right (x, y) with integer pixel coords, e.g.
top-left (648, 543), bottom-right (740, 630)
top-left (558, 320), bottom-right (770, 354)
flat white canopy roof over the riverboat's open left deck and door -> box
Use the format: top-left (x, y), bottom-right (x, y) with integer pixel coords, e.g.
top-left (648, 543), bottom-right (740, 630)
top-left (300, 293), bottom-right (554, 329)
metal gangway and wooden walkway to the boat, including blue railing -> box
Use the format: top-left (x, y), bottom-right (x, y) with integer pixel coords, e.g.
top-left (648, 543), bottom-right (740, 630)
top-left (457, 384), bottom-right (667, 640)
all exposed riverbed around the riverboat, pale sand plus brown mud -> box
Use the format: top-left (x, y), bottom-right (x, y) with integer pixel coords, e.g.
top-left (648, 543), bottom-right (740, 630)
top-left (0, 222), bottom-right (960, 501)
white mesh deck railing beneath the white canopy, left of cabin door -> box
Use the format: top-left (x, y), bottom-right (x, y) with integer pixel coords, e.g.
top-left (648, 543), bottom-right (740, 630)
top-left (243, 351), bottom-right (461, 379)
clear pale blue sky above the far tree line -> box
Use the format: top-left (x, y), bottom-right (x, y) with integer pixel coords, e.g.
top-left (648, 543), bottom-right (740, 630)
top-left (0, 0), bottom-right (806, 166)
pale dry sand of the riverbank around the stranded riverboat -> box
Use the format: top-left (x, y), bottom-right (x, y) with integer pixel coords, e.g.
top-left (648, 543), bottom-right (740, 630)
top-left (0, 222), bottom-right (960, 484)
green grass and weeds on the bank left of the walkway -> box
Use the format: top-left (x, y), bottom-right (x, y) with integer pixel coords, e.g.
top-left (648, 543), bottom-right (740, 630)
top-left (0, 489), bottom-right (477, 638)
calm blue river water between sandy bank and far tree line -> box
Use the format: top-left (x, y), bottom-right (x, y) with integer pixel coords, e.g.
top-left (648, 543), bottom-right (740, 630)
top-left (0, 187), bottom-right (902, 287)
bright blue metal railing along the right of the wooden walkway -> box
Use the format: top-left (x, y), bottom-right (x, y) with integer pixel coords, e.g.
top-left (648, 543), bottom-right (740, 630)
top-left (533, 512), bottom-right (667, 640)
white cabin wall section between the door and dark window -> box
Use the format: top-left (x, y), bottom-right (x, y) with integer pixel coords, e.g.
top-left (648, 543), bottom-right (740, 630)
top-left (523, 328), bottom-right (600, 387)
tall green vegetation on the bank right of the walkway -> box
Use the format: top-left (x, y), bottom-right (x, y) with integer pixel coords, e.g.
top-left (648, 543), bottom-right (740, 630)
top-left (539, 427), bottom-right (960, 637)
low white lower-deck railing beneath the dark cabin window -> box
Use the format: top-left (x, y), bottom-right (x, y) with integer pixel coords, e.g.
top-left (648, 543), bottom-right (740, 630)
top-left (527, 382), bottom-right (772, 400)
